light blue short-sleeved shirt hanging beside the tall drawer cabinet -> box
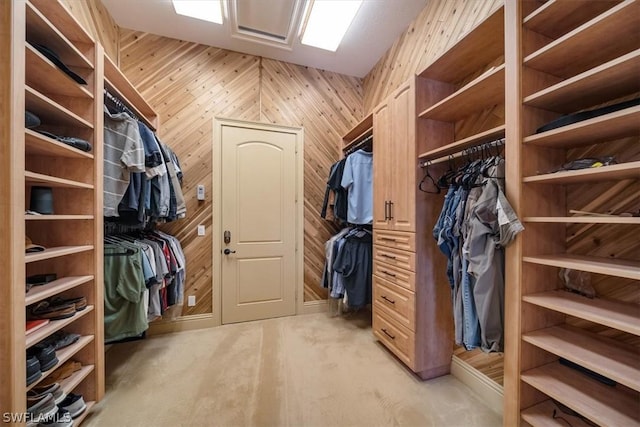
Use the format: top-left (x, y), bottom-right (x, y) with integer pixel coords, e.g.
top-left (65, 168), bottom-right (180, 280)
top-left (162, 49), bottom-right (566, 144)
top-left (341, 150), bottom-right (373, 224)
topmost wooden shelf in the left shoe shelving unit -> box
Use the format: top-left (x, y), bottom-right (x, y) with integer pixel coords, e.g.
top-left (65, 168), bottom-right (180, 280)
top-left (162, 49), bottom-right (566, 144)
top-left (26, 1), bottom-right (93, 71)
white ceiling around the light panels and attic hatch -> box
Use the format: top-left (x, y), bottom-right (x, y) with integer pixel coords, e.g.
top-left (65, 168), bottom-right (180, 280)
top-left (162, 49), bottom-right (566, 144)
top-left (102, 0), bottom-right (429, 77)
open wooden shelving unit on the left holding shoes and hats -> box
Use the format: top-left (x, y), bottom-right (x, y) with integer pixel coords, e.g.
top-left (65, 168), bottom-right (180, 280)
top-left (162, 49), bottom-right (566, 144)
top-left (0, 0), bottom-right (104, 425)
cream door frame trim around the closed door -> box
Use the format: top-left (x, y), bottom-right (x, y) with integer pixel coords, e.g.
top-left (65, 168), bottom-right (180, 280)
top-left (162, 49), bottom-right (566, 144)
top-left (211, 117), bottom-right (304, 325)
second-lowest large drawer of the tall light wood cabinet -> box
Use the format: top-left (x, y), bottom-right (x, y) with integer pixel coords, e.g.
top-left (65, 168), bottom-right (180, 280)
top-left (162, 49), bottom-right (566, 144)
top-left (373, 276), bottom-right (416, 332)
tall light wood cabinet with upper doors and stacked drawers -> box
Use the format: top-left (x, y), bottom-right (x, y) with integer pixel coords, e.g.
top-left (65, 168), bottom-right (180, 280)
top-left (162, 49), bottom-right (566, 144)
top-left (373, 78), bottom-right (452, 379)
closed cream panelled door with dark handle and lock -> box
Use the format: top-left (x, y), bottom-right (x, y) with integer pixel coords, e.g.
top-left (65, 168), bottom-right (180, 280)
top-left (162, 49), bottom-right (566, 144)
top-left (221, 125), bottom-right (297, 323)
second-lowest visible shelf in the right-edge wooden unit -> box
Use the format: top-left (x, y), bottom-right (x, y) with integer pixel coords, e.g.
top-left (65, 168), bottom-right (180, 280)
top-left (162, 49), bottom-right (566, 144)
top-left (521, 363), bottom-right (638, 426)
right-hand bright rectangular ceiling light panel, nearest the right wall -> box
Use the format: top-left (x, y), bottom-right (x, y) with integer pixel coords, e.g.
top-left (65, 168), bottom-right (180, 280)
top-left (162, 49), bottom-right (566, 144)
top-left (302, 0), bottom-right (362, 52)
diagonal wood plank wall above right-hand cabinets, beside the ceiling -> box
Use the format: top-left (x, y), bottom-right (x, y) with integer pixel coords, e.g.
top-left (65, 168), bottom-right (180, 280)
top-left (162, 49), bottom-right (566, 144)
top-left (364, 0), bottom-right (504, 113)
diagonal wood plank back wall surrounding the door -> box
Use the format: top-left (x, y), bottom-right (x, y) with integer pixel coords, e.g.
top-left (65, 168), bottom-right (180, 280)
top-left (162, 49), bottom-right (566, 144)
top-left (120, 29), bottom-right (363, 315)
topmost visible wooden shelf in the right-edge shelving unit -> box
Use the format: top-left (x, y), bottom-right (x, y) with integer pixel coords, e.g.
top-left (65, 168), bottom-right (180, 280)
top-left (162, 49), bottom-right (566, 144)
top-left (524, 0), bottom-right (621, 39)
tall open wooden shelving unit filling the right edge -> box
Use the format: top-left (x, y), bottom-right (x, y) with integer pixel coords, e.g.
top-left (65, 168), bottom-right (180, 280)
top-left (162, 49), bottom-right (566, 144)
top-left (504, 1), bottom-right (640, 426)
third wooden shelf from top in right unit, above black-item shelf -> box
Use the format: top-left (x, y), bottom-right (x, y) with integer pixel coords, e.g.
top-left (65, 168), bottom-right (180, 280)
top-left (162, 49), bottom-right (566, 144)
top-left (523, 49), bottom-right (640, 114)
